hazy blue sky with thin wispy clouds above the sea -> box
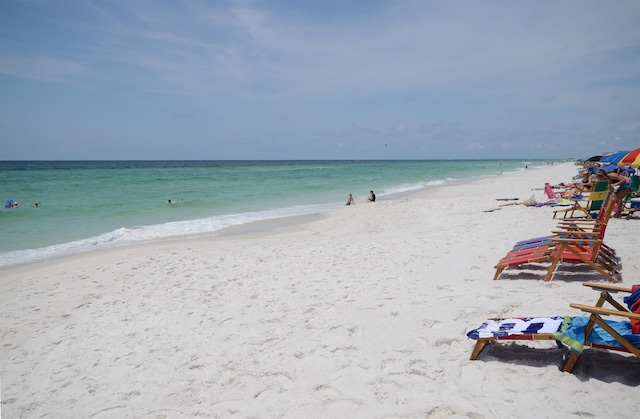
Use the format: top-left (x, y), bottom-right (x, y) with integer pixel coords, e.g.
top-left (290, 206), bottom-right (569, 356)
top-left (0, 0), bottom-right (640, 160)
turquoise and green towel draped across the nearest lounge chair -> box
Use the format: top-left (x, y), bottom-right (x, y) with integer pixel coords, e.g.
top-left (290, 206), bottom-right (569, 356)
top-left (553, 316), bottom-right (640, 353)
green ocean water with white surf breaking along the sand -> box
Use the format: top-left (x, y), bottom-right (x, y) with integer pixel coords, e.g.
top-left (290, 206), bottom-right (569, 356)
top-left (0, 160), bottom-right (548, 268)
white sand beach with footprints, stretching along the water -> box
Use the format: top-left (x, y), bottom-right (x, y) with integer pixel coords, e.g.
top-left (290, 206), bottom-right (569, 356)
top-left (0, 163), bottom-right (640, 418)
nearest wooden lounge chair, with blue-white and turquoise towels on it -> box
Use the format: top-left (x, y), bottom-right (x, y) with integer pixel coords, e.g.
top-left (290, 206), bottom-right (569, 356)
top-left (467, 282), bottom-right (640, 372)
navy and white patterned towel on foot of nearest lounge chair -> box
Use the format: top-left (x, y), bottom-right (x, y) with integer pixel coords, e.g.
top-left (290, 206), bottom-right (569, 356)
top-left (467, 316), bottom-right (564, 339)
